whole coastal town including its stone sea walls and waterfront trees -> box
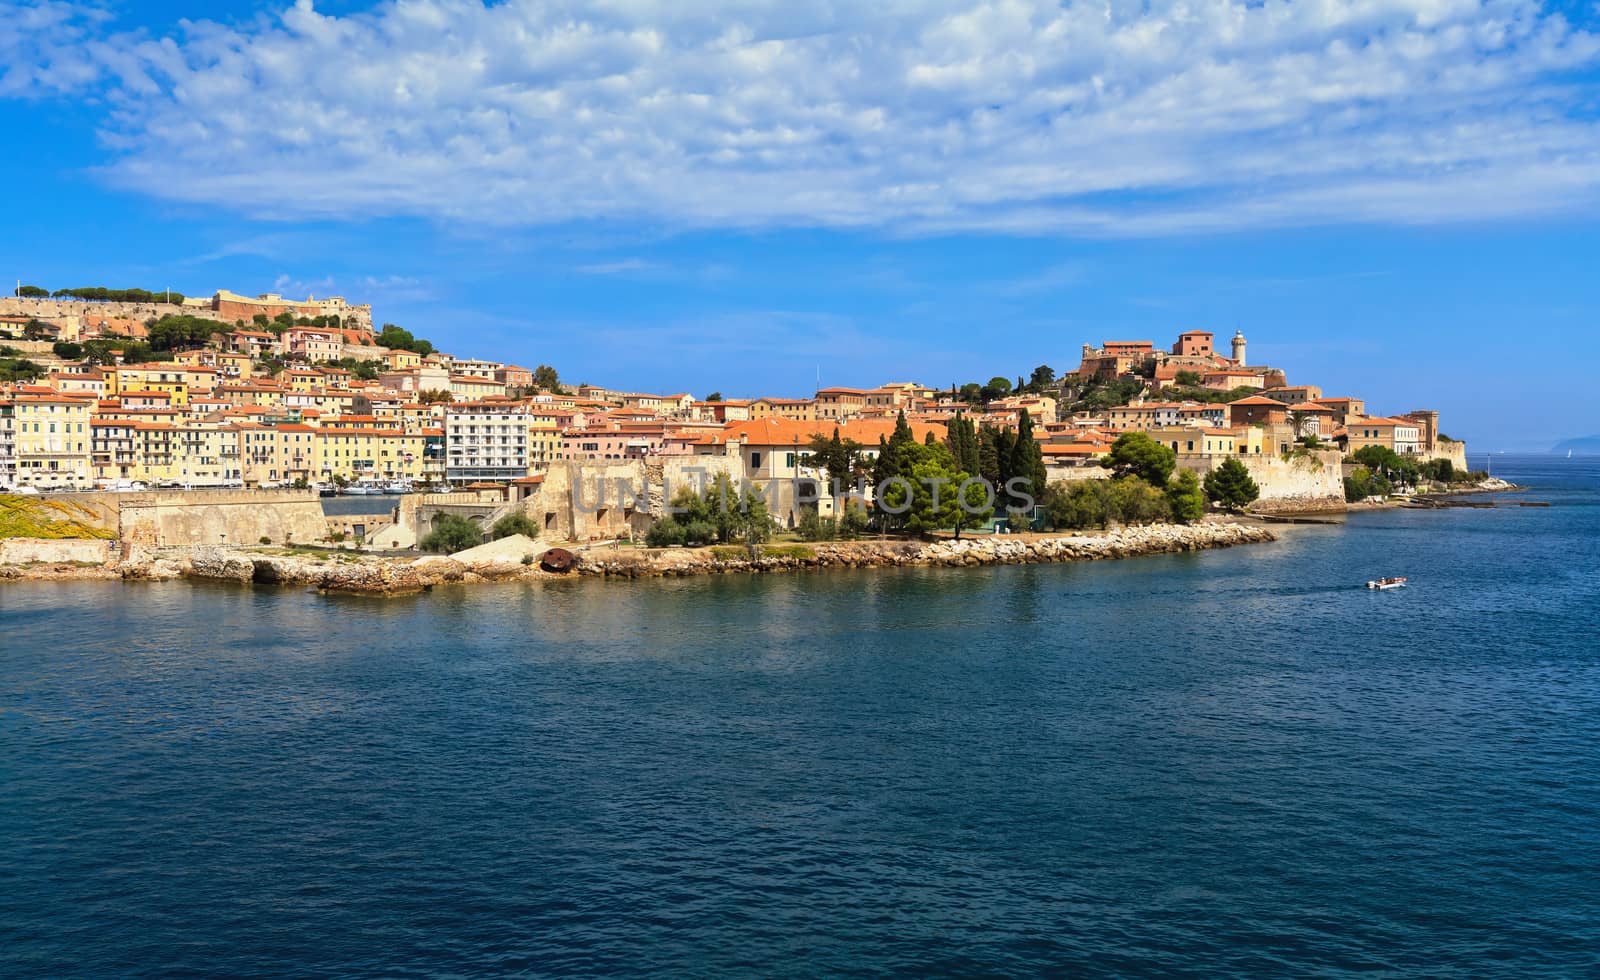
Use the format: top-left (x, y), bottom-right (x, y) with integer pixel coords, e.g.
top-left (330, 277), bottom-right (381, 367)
top-left (0, 287), bottom-right (1467, 570)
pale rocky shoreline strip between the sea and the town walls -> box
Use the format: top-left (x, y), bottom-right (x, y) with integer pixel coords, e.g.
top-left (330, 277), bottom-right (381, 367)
top-left (0, 520), bottom-right (1277, 596)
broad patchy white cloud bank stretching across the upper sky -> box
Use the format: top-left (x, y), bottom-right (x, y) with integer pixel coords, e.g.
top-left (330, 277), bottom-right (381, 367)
top-left (9, 0), bottom-right (1600, 235)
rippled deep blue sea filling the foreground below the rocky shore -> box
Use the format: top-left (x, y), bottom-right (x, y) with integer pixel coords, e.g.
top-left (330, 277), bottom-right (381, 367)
top-left (0, 458), bottom-right (1600, 977)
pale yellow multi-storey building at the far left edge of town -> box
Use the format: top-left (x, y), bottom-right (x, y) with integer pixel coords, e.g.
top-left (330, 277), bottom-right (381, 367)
top-left (0, 394), bottom-right (94, 490)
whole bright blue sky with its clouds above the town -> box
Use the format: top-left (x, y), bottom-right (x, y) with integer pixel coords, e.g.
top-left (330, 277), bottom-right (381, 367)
top-left (0, 0), bottom-right (1600, 448)
